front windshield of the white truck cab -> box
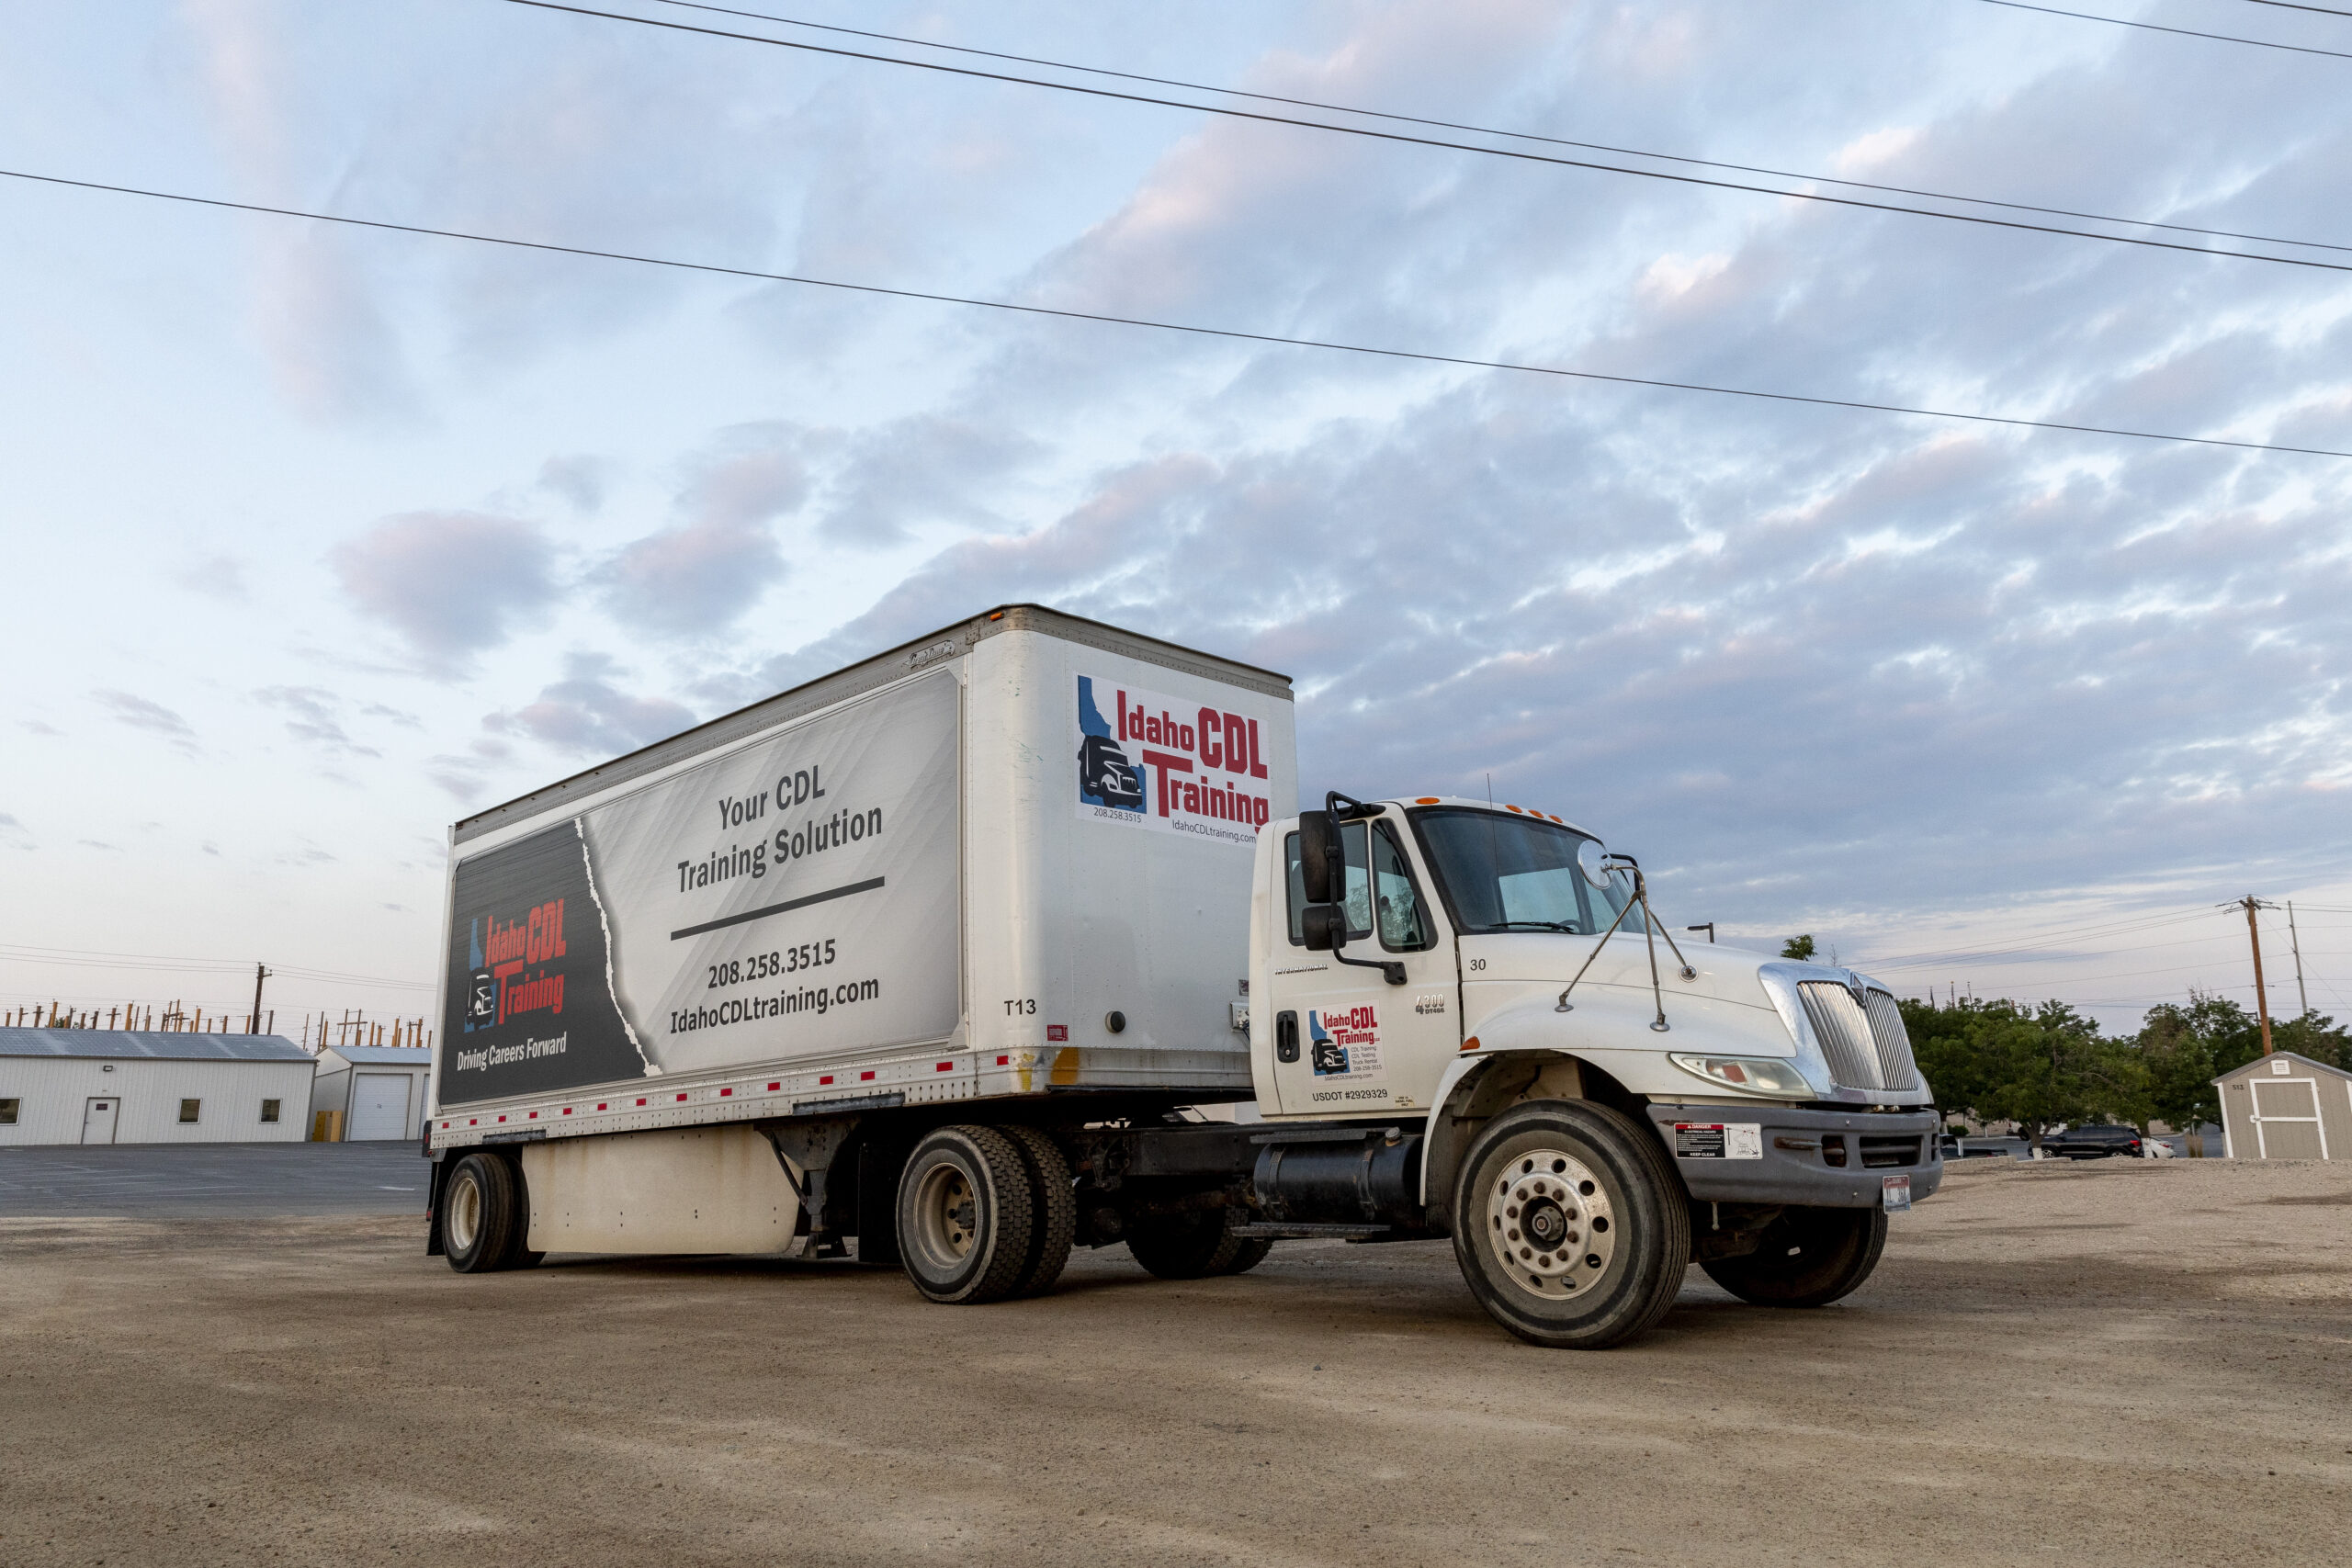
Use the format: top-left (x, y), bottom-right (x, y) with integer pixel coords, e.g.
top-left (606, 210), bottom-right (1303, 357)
top-left (1414, 807), bottom-right (1642, 936)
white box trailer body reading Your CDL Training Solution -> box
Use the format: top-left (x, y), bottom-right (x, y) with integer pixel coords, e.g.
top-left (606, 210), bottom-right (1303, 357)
top-left (430, 609), bottom-right (1296, 1170)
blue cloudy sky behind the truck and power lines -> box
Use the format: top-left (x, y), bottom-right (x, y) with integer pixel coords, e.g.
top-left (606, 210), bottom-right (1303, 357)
top-left (0, 0), bottom-right (2352, 1027)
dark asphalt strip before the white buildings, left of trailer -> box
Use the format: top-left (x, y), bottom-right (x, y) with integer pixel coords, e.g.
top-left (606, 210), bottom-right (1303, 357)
top-left (0, 1140), bottom-right (430, 1218)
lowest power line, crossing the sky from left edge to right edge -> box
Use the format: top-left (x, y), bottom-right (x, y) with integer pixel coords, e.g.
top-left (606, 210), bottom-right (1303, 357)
top-left (18, 169), bottom-right (2352, 458)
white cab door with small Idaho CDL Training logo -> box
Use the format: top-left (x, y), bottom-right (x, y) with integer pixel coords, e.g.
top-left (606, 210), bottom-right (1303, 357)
top-left (1263, 820), bottom-right (1461, 1117)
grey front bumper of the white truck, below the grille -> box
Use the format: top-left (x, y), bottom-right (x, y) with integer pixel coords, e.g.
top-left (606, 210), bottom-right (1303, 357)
top-left (1649, 1102), bottom-right (1943, 1208)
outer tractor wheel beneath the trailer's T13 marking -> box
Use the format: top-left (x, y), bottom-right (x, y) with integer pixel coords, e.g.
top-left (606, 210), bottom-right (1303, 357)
top-left (899, 1126), bottom-right (1037, 1304)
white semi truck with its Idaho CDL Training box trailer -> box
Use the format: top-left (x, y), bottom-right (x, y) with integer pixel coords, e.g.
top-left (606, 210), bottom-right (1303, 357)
top-left (425, 604), bottom-right (1943, 1347)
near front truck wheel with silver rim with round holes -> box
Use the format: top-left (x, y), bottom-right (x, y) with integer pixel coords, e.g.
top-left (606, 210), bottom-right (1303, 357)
top-left (1453, 1100), bottom-right (1691, 1349)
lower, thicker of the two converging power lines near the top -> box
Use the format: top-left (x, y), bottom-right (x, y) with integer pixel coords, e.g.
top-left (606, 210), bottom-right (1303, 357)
top-left (503, 0), bottom-right (2352, 273)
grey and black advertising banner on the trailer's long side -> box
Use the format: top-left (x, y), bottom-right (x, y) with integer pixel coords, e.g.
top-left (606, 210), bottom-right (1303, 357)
top-left (435, 670), bottom-right (962, 1112)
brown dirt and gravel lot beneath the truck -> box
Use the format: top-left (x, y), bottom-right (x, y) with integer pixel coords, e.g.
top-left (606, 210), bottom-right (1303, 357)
top-left (0, 1161), bottom-right (2352, 1568)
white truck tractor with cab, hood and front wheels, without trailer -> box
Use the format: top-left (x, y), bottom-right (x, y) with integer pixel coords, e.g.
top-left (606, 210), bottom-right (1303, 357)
top-left (1249, 795), bottom-right (1943, 1345)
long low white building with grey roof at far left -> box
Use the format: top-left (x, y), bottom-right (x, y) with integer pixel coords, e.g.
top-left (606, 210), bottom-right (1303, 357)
top-left (0, 1030), bottom-right (318, 1145)
